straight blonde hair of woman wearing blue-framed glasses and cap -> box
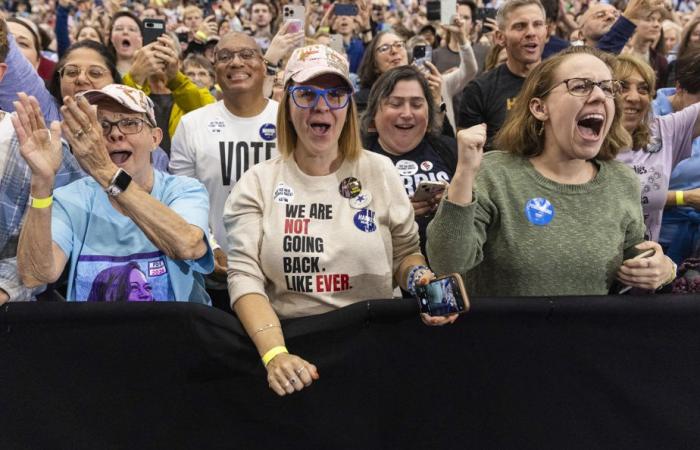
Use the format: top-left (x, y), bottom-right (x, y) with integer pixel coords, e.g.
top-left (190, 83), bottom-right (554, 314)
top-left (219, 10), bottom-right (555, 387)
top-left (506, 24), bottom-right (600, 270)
top-left (277, 80), bottom-right (362, 161)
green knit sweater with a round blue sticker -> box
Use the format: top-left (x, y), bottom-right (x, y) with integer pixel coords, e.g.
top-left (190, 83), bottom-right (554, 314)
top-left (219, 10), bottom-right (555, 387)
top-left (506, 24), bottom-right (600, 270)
top-left (427, 151), bottom-right (644, 296)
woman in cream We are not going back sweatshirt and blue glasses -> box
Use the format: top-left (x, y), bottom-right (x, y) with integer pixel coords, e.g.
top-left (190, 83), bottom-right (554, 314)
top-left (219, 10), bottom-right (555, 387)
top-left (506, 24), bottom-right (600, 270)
top-left (224, 45), bottom-right (456, 395)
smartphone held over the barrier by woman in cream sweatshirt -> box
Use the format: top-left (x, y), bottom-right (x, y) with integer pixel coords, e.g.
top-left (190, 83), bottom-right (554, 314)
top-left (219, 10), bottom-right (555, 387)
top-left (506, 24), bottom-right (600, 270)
top-left (416, 273), bottom-right (469, 316)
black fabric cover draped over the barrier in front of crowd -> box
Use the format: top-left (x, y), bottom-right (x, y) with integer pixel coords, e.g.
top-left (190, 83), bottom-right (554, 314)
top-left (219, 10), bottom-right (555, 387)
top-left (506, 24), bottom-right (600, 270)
top-left (0, 296), bottom-right (700, 450)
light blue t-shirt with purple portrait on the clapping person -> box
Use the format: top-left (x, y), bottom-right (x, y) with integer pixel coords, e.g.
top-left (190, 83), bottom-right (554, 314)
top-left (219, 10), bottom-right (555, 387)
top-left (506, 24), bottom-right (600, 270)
top-left (51, 170), bottom-right (214, 304)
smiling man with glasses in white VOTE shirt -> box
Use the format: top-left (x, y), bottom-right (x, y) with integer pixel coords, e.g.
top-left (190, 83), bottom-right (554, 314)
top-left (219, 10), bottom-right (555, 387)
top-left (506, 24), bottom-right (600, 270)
top-left (170, 33), bottom-right (278, 310)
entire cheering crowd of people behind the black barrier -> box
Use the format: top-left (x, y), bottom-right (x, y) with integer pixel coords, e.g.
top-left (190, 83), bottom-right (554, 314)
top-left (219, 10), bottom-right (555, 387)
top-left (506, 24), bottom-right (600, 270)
top-left (0, 0), bottom-right (700, 395)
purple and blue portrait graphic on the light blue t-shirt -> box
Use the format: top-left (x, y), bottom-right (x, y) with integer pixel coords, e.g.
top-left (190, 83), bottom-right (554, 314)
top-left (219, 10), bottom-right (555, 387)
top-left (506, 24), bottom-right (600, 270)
top-left (75, 252), bottom-right (175, 302)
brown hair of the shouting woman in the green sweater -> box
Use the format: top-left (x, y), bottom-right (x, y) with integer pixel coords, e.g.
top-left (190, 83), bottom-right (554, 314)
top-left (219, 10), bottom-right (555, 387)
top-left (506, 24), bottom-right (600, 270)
top-left (495, 45), bottom-right (631, 161)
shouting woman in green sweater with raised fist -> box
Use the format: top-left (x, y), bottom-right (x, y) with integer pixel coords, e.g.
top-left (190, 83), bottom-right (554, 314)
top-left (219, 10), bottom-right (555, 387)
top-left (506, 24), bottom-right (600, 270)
top-left (427, 47), bottom-right (675, 296)
